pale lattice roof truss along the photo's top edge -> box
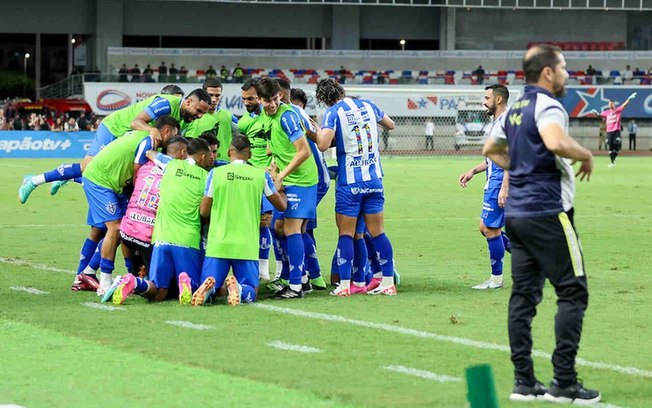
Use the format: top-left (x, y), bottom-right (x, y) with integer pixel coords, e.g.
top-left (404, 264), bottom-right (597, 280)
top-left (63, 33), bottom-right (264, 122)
top-left (157, 0), bottom-right (652, 11)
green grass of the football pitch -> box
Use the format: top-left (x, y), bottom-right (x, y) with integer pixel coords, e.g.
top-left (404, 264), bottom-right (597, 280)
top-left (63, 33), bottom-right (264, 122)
top-left (0, 158), bottom-right (652, 407)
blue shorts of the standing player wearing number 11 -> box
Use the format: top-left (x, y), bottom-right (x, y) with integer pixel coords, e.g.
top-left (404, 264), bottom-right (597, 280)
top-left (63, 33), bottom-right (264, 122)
top-left (335, 179), bottom-right (385, 218)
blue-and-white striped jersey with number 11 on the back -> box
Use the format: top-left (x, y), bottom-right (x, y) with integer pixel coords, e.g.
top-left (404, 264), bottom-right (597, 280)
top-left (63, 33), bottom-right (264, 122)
top-left (322, 97), bottom-right (385, 185)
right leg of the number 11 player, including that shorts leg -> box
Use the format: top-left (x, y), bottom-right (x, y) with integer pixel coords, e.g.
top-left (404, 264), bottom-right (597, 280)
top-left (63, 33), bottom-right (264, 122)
top-left (360, 180), bottom-right (396, 295)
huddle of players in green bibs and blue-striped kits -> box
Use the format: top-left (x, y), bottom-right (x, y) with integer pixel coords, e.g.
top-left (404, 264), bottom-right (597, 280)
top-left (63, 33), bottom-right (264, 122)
top-left (18, 78), bottom-right (398, 306)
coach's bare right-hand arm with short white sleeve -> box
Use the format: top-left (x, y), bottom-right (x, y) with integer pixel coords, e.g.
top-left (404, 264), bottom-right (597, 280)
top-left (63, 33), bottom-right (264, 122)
top-left (537, 108), bottom-right (593, 181)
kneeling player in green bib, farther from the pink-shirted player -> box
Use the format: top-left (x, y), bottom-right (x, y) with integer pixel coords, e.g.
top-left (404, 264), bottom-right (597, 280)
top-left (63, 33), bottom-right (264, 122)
top-left (192, 136), bottom-right (287, 306)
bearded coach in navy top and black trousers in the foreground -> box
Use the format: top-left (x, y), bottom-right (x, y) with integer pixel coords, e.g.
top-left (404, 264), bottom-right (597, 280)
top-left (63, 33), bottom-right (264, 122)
top-left (484, 45), bottom-right (600, 403)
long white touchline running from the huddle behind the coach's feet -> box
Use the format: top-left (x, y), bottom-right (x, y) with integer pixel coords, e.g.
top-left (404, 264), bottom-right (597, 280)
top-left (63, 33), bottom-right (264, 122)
top-left (252, 303), bottom-right (652, 378)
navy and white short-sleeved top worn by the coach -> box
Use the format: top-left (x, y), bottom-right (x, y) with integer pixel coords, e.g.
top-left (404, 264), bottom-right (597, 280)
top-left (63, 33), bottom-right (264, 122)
top-left (491, 85), bottom-right (575, 218)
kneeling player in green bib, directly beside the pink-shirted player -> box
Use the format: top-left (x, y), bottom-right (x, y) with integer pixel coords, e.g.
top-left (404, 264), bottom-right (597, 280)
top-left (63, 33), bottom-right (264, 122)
top-left (113, 139), bottom-right (213, 304)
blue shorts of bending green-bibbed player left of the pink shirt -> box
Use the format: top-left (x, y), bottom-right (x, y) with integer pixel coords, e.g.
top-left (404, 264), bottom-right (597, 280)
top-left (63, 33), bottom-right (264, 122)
top-left (82, 176), bottom-right (128, 228)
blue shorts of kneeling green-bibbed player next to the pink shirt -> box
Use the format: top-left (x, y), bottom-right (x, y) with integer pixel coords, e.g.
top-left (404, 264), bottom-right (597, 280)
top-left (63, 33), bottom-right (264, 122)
top-left (149, 242), bottom-right (201, 291)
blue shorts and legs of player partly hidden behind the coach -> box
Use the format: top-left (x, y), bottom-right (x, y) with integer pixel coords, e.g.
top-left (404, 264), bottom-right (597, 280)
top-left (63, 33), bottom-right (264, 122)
top-left (473, 189), bottom-right (505, 289)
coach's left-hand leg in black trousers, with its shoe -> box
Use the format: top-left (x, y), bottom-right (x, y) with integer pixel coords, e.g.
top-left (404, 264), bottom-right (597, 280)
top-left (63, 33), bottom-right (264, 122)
top-left (507, 218), bottom-right (545, 401)
